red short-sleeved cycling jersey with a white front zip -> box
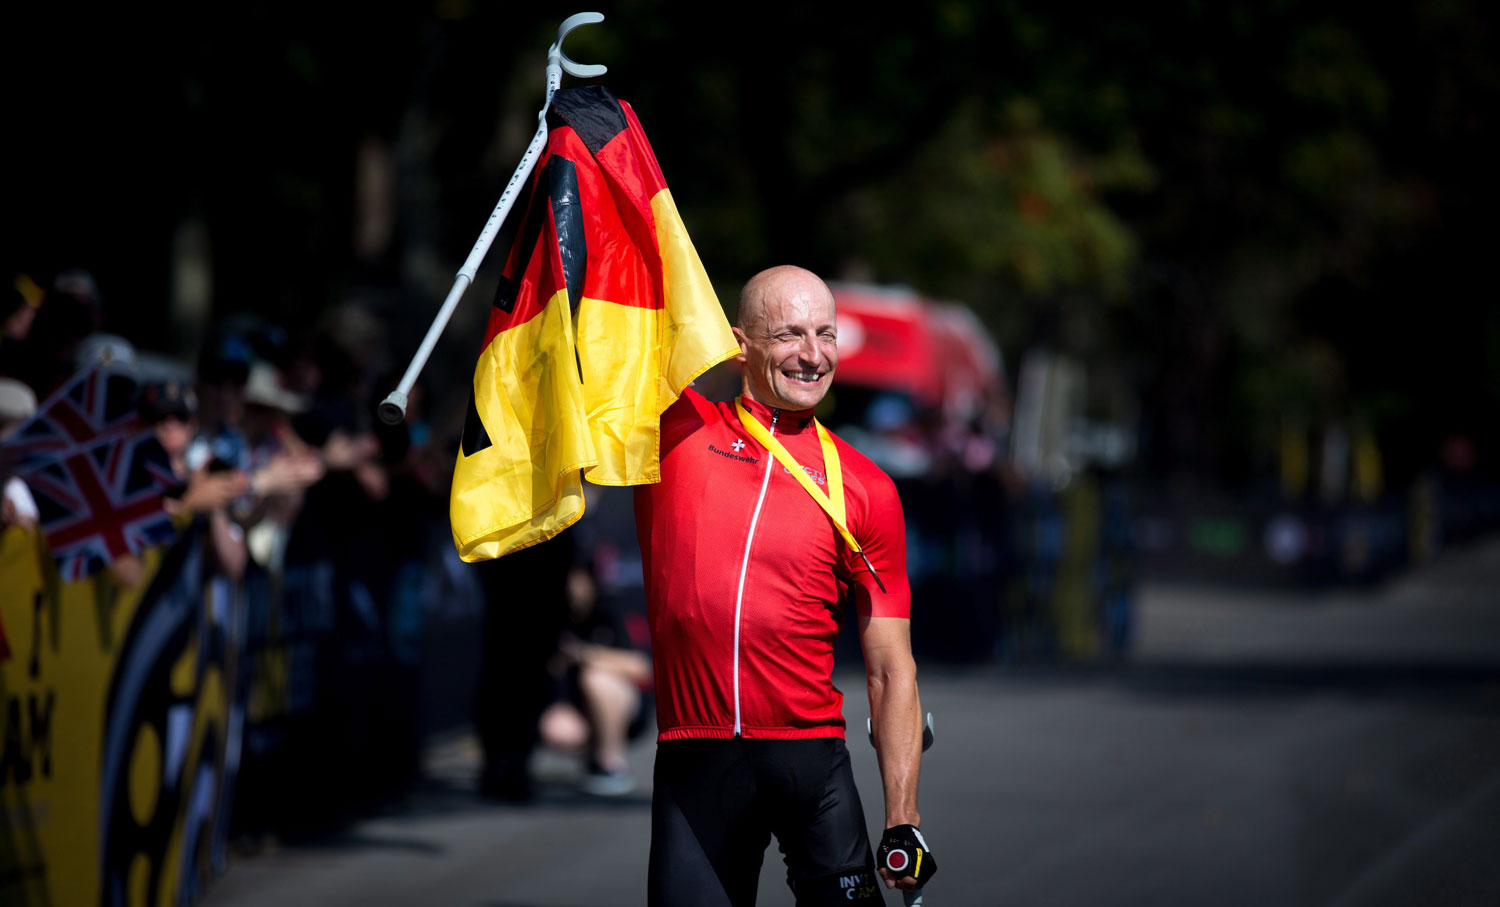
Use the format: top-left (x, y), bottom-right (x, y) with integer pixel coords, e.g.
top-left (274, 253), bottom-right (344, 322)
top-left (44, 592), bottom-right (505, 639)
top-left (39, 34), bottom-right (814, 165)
top-left (636, 390), bottom-right (911, 741)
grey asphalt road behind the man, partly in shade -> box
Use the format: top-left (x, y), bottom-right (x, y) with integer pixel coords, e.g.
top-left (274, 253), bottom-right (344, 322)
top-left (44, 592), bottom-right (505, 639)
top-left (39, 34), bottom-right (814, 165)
top-left (203, 540), bottom-right (1500, 907)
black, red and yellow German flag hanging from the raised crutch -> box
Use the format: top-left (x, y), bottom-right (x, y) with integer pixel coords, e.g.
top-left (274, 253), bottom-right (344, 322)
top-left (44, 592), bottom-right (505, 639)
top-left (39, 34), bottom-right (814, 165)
top-left (449, 85), bottom-right (740, 561)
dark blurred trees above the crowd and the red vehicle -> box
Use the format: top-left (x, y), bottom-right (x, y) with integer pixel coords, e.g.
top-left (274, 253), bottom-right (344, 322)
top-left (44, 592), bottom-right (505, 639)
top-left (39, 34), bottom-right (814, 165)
top-left (3, 0), bottom-right (1500, 515)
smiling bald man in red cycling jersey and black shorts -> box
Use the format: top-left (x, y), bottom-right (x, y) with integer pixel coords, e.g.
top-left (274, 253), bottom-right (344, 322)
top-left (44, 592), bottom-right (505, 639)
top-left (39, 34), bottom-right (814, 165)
top-left (636, 267), bottom-right (935, 907)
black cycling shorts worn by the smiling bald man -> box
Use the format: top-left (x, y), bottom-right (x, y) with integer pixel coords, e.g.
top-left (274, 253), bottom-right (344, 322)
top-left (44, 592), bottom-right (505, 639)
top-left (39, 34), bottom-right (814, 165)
top-left (647, 738), bottom-right (882, 907)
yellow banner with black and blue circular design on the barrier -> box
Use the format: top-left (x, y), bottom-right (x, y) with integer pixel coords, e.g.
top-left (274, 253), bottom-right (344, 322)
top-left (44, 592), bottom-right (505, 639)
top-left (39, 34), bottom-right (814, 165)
top-left (0, 526), bottom-right (243, 906)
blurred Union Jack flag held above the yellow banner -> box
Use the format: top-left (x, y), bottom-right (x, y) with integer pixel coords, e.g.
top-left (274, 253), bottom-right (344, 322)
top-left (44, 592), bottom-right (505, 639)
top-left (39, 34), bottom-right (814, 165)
top-left (5, 366), bottom-right (182, 582)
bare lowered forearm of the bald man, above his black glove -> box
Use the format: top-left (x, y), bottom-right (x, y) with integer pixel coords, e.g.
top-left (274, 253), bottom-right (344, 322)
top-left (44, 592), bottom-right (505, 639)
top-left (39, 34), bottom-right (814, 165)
top-left (869, 658), bottom-right (923, 828)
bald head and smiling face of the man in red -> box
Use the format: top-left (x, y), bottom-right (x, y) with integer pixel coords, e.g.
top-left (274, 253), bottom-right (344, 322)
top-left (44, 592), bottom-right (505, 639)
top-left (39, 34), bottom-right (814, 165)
top-left (735, 267), bottom-right (839, 409)
